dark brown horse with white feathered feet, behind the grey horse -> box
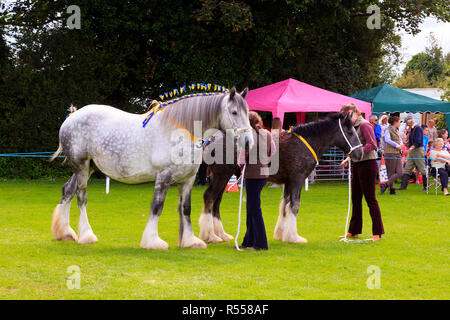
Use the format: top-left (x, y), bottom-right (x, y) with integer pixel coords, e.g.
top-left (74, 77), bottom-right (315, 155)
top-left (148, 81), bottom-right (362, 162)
top-left (199, 113), bottom-right (362, 243)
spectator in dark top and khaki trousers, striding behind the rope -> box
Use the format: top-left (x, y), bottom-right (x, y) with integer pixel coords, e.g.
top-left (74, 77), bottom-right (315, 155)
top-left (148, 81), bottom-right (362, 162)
top-left (397, 116), bottom-right (428, 191)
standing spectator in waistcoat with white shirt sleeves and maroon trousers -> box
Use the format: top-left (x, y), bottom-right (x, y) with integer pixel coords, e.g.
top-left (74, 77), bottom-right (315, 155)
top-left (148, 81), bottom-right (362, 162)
top-left (380, 116), bottom-right (403, 195)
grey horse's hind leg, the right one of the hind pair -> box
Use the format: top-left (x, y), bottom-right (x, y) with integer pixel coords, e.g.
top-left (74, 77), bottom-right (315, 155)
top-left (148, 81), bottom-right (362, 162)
top-left (76, 160), bottom-right (98, 244)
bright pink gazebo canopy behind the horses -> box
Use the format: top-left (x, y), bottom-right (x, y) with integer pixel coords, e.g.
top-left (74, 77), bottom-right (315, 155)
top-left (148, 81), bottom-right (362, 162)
top-left (246, 79), bottom-right (372, 123)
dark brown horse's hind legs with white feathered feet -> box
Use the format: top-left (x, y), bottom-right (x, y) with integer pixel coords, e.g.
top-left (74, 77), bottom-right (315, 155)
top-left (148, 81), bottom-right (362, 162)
top-left (199, 167), bottom-right (231, 243)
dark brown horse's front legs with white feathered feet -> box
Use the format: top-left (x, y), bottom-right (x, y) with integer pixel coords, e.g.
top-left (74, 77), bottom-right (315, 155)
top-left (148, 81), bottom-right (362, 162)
top-left (274, 179), bottom-right (308, 243)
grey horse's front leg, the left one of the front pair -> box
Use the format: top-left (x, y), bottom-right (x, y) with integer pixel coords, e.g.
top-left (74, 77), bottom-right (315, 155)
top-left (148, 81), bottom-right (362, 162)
top-left (141, 172), bottom-right (171, 250)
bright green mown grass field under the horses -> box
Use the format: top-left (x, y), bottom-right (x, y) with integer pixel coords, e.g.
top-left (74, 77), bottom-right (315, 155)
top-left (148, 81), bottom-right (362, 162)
top-left (0, 180), bottom-right (450, 299)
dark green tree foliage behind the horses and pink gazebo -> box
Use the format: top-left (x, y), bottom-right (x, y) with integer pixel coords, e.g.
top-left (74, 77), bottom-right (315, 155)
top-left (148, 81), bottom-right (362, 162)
top-left (0, 0), bottom-right (450, 178)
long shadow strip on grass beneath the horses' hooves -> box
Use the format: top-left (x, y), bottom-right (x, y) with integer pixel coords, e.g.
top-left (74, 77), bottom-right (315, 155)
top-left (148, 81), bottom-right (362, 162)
top-left (33, 235), bottom-right (368, 264)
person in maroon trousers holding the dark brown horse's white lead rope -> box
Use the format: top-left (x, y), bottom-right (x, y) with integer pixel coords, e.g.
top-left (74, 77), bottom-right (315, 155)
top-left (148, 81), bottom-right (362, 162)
top-left (341, 103), bottom-right (384, 241)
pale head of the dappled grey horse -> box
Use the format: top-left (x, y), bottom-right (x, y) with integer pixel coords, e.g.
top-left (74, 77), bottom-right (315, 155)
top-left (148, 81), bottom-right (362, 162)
top-left (220, 87), bottom-right (253, 148)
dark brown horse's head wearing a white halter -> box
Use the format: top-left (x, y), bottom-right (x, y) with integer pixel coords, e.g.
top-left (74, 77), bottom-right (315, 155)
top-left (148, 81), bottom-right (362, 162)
top-left (334, 112), bottom-right (362, 159)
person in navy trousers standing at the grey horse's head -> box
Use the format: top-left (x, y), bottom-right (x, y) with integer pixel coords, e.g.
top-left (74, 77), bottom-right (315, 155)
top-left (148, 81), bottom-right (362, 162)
top-left (239, 111), bottom-right (276, 250)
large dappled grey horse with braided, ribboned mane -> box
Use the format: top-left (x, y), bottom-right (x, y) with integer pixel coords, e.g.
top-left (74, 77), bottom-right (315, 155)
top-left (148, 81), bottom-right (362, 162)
top-left (51, 88), bottom-right (253, 249)
